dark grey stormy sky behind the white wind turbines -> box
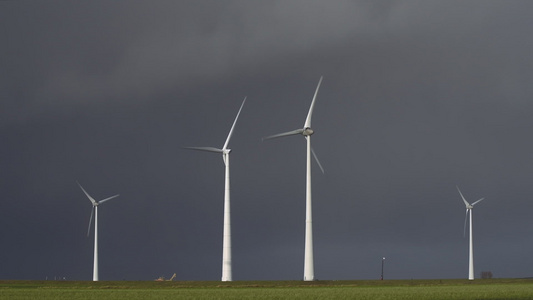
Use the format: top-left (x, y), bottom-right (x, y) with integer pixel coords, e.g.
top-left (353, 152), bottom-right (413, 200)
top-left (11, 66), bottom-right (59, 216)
top-left (0, 0), bottom-right (533, 280)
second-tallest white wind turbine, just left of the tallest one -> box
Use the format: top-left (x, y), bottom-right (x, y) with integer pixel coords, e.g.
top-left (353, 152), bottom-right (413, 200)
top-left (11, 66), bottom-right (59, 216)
top-left (185, 97), bottom-right (246, 281)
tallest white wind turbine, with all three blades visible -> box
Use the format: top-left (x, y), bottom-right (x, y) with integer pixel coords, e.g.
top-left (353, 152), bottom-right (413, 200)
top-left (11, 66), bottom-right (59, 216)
top-left (263, 77), bottom-right (324, 281)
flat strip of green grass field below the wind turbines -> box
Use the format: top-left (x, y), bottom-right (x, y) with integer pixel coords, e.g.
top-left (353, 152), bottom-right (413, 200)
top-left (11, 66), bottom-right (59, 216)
top-left (0, 279), bottom-right (533, 300)
